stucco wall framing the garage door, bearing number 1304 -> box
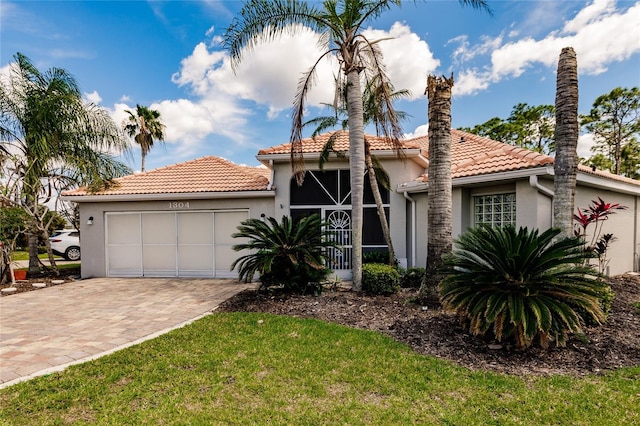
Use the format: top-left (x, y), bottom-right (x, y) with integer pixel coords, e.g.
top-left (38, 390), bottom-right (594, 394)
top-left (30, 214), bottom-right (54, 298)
top-left (80, 197), bottom-right (274, 278)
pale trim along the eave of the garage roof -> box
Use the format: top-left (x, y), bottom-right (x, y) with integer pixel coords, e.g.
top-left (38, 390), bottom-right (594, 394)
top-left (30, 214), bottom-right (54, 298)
top-left (60, 191), bottom-right (276, 203)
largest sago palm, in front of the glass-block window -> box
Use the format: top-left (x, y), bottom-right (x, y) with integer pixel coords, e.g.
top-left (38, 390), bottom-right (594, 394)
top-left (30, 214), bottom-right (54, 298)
top-left (439, 226), bottom-right (607, 348)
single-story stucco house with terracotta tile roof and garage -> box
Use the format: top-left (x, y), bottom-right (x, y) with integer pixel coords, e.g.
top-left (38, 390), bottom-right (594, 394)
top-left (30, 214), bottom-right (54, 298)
top-left (63, 130), bottom-right (640, 278)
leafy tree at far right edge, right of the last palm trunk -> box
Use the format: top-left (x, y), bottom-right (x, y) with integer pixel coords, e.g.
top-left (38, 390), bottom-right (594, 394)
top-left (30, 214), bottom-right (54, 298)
top-left (581, 87), bottom-right (640, 177)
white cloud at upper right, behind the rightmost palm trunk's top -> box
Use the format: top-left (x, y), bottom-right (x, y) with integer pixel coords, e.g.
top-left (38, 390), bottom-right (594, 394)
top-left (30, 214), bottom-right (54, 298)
top-left (454, 0), bottom-right (640, 95)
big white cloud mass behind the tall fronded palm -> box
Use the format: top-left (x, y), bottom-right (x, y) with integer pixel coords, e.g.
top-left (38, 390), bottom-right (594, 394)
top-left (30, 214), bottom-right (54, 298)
top-left (160, 23), bottom-right (439, 155)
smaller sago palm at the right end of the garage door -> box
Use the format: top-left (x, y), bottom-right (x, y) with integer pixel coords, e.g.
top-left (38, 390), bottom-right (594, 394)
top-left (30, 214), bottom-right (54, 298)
top-left (231, 214), bottom-right (336, 294)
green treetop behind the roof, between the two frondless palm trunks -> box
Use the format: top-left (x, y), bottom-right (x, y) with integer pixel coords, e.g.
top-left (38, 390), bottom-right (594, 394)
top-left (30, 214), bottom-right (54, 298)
top-left (461, 103), bottom-right (555, 154)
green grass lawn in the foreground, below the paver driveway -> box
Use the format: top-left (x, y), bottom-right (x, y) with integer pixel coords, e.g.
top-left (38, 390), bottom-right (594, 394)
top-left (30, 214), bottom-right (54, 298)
top-left (0, 313), bottom-right (640, 425)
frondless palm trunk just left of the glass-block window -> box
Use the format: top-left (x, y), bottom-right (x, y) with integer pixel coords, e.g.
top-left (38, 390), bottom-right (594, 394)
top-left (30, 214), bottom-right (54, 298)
top-left (420, 75), bottom-right (453, 297)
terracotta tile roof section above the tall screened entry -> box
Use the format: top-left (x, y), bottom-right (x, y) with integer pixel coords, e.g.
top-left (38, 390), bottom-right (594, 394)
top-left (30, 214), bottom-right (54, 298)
top-left (258, 130), bottom-right (419, 155)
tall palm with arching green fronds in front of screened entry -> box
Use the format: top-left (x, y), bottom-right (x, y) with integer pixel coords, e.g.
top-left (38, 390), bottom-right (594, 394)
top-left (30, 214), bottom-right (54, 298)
top-left (224, 0), bottom-right (486, 290)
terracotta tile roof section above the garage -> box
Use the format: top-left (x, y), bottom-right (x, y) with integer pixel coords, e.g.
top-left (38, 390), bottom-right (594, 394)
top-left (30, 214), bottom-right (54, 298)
top-left (63, 156), bottom-right (271, 196)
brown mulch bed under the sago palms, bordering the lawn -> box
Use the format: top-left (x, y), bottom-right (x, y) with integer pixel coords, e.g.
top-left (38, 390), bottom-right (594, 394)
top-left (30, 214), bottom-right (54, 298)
top-left (218, 275), bottom-right (640, 376)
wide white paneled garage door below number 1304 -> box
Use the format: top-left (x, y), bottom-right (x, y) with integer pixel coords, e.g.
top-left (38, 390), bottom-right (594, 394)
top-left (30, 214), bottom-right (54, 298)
top-left (105, 210), bottom-right (249, 278)
